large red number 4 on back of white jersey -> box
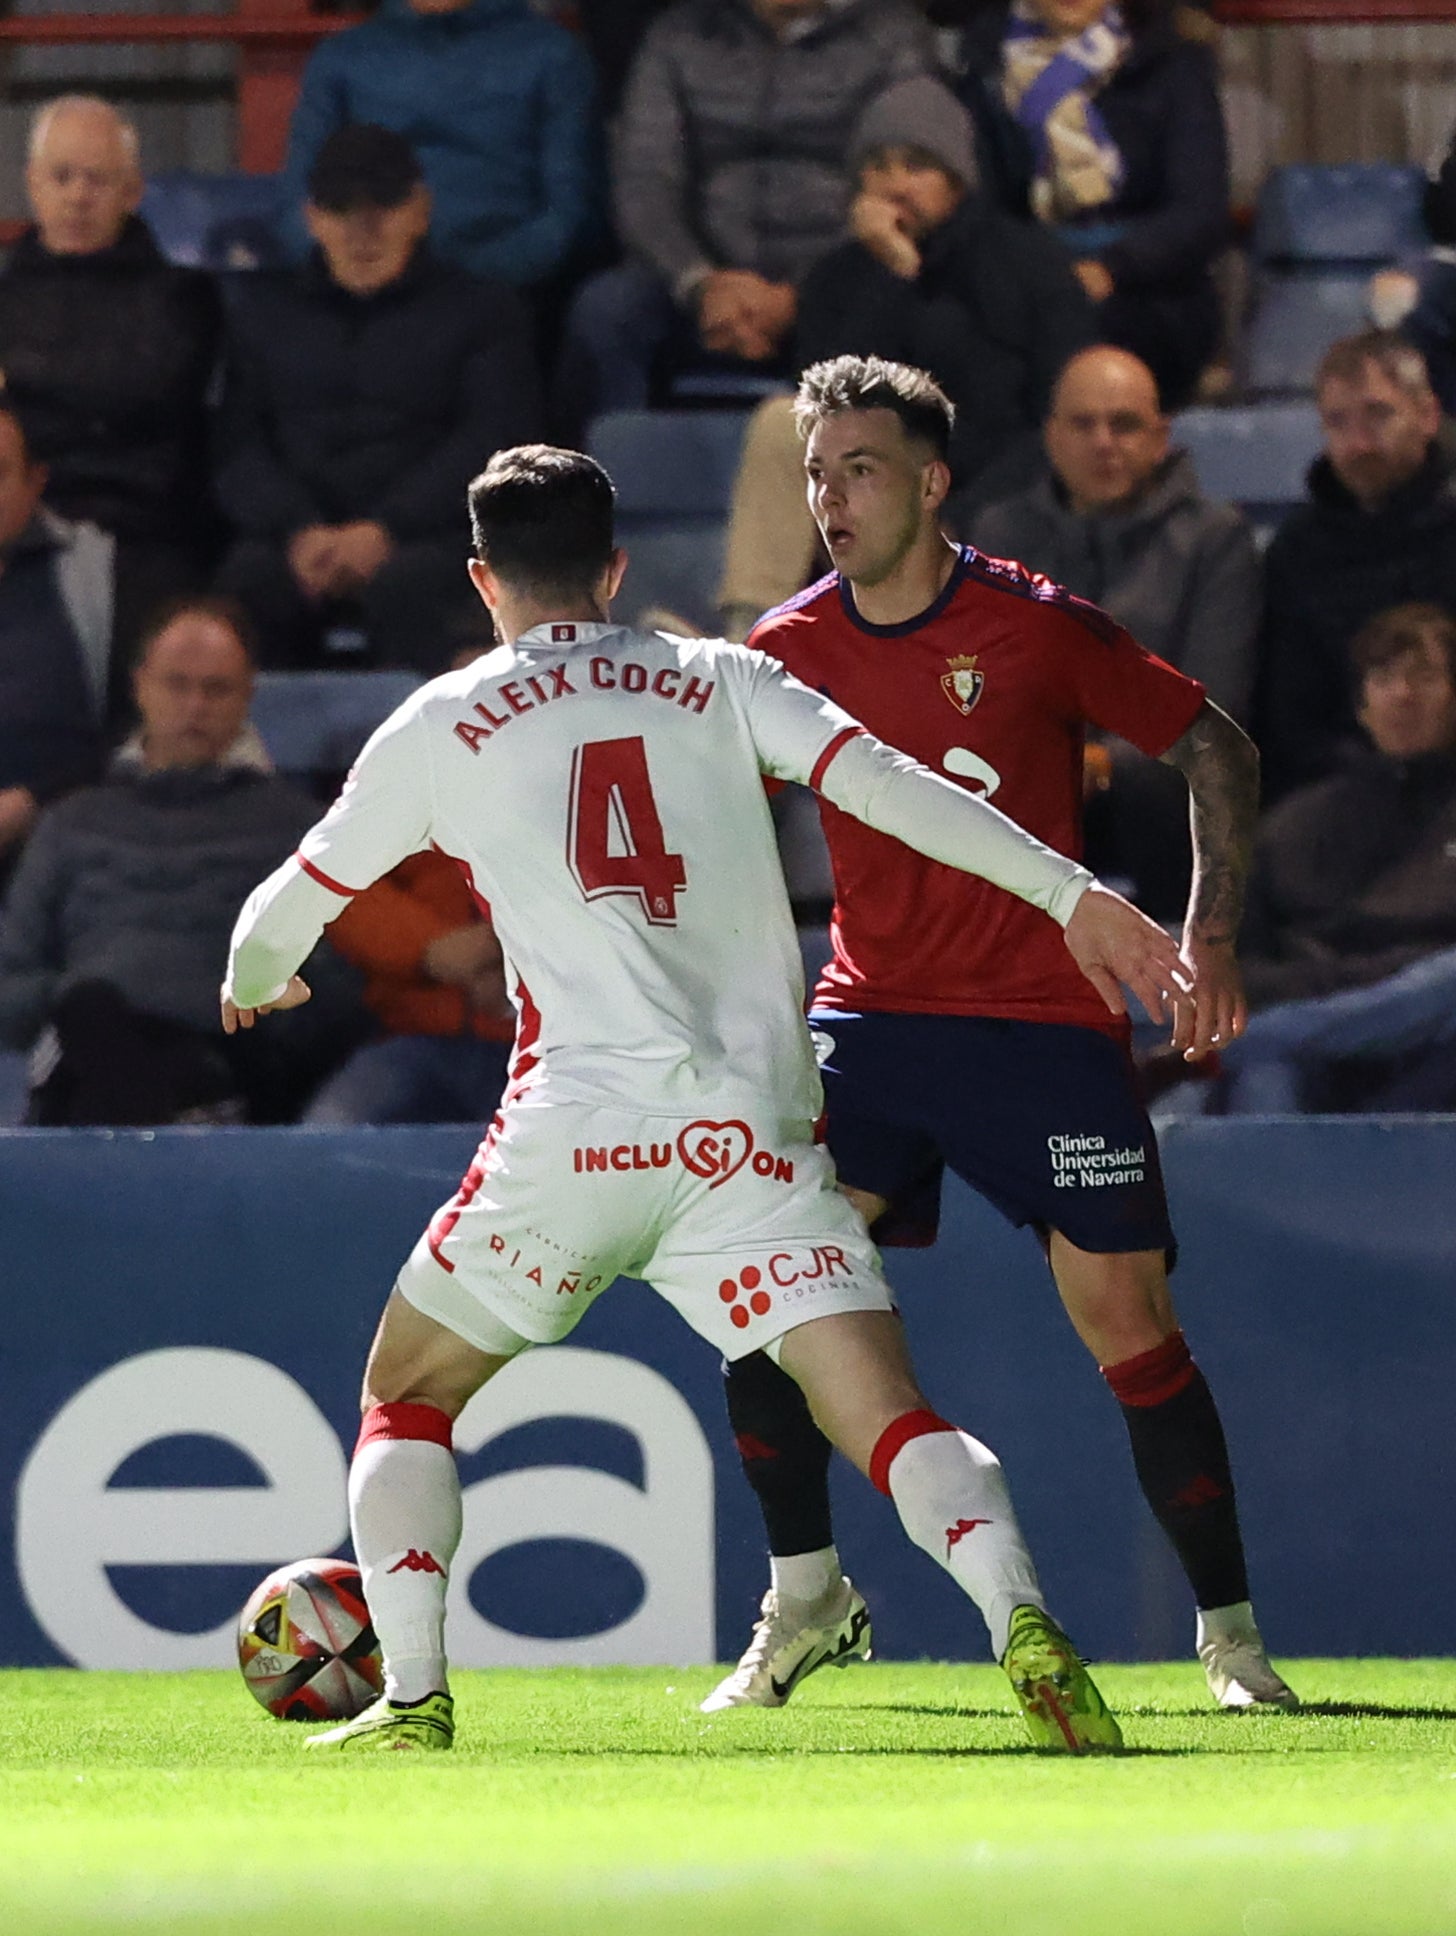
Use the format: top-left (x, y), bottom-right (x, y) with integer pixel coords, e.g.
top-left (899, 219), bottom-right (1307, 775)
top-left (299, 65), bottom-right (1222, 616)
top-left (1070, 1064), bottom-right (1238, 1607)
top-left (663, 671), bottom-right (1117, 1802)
top-left (567, 736), bottom-right (687, 927)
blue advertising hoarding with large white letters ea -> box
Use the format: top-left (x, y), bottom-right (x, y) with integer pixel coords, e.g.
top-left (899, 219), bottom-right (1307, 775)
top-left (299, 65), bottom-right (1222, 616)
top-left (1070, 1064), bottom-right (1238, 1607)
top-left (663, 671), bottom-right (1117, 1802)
top-left (0, 1119), bottom-right (1456, 1669)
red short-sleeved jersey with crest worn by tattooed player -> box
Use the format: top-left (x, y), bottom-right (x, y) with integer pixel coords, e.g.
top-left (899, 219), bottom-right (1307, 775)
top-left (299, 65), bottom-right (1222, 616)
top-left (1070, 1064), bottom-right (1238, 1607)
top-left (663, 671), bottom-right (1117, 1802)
top-left (749, 546), bottom-right (1202, 1032)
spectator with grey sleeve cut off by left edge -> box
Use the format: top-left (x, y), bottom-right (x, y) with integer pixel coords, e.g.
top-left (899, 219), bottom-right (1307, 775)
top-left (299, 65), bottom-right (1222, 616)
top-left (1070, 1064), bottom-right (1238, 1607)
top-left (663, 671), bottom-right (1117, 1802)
top-left (0, 405), bottom-right (114, 885)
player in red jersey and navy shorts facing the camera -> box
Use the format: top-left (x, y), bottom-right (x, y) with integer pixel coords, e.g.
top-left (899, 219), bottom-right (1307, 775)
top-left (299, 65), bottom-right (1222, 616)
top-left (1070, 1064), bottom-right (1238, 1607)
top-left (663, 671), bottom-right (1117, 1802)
top-left (703, 356), bottom-right (1297, 1711)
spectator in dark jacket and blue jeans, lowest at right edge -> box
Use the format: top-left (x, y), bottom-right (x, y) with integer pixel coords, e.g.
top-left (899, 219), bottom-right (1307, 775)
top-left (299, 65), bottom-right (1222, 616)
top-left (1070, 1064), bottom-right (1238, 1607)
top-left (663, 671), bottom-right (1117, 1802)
top-left (1224, 604), bottom-right (1456, 1111)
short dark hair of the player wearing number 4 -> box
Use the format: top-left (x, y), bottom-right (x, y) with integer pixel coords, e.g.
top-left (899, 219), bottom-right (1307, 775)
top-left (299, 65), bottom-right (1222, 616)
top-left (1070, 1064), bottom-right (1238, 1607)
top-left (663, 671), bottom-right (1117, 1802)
top-left (470, 443), bottom-right (616, 596)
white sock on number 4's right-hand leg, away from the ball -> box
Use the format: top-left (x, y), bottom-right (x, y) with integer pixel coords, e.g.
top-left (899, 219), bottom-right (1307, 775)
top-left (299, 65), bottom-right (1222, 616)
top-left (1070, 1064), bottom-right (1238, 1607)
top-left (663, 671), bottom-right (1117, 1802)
top-left (889, 1433), bottom-right (1046, 1661)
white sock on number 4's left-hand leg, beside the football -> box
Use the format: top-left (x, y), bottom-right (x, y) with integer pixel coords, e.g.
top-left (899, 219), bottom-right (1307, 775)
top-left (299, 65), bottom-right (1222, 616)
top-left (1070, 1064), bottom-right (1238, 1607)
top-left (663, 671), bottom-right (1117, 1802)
top-left (349, 1438), bottom-right (461, 1700)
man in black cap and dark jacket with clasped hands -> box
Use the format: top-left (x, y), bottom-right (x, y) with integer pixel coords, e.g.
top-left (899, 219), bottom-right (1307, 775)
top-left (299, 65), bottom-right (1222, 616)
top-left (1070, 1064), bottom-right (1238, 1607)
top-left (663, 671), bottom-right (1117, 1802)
top-left (217, 126), bottom-right (540, 674)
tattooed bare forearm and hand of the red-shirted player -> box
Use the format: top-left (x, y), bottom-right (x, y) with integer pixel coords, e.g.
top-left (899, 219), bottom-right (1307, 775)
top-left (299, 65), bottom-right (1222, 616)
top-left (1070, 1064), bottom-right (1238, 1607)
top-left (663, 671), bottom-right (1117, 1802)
top-left (1162, 699), bottom-right (1259, 1063)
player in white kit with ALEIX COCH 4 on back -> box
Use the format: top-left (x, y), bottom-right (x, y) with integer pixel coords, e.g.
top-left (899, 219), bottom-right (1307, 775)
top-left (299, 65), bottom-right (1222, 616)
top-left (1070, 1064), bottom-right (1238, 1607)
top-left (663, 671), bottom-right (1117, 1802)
top-left (223, 445), bottom-right (1187, 1752)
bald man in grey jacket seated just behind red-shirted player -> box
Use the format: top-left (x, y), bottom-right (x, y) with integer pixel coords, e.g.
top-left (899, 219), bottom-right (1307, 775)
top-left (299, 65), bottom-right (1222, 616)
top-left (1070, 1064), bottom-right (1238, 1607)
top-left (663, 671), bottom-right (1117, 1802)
top-left (970, 345), bottom-right (1260, 920)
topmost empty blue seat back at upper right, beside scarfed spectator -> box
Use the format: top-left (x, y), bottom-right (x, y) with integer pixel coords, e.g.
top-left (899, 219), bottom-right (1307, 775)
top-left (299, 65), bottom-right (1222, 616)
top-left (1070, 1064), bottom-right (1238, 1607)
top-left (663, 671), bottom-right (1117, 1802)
top-left (1253, 161), bottom-right (1431, 267)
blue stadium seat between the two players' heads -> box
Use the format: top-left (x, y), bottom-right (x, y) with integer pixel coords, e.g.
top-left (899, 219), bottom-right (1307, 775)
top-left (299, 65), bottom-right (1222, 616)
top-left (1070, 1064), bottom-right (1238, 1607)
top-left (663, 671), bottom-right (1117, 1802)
top-left (587, 410), bottom-right (747, 629)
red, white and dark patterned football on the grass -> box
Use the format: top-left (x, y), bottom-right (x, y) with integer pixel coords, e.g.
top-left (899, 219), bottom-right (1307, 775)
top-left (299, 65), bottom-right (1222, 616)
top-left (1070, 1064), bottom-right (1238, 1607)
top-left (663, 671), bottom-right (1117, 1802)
top-left (238, 1560), bottom-right (383, 1721)
